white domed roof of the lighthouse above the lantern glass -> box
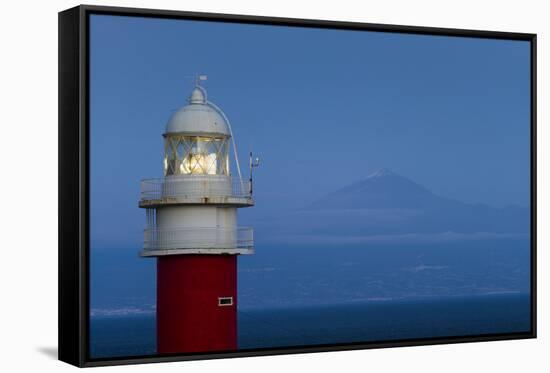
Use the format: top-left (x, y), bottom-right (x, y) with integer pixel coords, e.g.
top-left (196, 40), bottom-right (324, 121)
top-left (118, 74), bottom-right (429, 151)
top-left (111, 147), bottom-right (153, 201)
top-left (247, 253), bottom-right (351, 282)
top-left (165, 86), bottom-right (230, 137)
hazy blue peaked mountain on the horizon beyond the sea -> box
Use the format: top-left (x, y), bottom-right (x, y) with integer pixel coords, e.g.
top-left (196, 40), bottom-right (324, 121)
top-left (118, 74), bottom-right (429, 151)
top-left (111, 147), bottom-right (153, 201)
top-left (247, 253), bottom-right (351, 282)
top-left (255, 169), bottom-right (529, 242)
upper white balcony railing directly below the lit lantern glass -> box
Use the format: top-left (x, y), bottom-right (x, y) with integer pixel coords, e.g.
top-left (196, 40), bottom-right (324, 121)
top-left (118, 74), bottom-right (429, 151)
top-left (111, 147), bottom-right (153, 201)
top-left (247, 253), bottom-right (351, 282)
top-left (140, 175), bottom-right (251, 201)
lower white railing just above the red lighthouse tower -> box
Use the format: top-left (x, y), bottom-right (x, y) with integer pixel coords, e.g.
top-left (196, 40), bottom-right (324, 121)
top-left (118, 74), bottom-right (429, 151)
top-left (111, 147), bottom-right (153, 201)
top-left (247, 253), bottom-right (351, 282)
top-left (143, 227), bottom-right (254, 250)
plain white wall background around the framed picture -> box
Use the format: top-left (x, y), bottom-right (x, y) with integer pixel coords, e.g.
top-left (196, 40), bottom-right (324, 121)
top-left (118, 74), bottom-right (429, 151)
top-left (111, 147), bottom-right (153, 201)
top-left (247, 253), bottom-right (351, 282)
top-left (0, 0), bottom-right (550, 373)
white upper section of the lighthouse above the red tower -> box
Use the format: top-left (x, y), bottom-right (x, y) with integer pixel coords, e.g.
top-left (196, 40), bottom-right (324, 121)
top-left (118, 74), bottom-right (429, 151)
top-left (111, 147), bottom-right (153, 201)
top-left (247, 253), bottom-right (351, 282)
top-left (140, 80), bottom-right (254, 256)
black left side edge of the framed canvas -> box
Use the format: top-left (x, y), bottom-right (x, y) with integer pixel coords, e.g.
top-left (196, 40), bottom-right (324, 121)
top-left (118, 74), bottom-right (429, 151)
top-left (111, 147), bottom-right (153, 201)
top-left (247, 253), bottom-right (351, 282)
top-left (58, 7), bottom-right (84, 366)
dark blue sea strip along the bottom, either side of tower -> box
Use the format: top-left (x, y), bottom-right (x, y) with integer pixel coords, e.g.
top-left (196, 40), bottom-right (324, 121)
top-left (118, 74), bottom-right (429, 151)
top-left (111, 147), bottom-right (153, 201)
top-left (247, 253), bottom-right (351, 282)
top-left (90, 292), bottom-right (531, 358)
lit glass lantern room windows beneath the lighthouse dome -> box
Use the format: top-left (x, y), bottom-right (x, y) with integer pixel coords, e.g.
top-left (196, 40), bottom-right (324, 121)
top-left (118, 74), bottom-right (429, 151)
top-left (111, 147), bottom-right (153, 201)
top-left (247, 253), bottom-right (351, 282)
top-left (164, 135), bottom-right (229, 176)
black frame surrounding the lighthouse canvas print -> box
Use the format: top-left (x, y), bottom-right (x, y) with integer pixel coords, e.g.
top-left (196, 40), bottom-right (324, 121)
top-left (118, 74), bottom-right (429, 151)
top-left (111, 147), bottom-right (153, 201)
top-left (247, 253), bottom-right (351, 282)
top-left (58, 5), bottom-right (537, 367)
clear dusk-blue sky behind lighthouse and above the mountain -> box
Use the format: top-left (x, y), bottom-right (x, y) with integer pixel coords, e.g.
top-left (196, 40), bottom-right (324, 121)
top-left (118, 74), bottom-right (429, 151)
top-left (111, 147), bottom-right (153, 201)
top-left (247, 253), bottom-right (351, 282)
top-left (90, 15), bottom-right (530, 251)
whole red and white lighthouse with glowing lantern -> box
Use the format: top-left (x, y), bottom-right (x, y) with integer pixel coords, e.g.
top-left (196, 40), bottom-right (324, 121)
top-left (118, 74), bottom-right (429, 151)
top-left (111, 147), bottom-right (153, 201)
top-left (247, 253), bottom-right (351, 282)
top-left (139, 76), bottom-right (257, 354)
